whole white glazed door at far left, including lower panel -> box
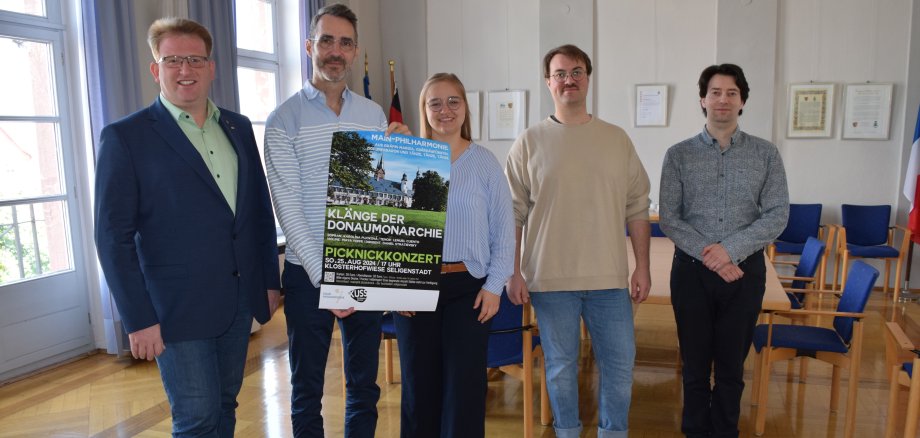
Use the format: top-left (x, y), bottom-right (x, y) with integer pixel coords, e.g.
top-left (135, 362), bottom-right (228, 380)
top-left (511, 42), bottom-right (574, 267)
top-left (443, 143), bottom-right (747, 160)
top-left (0, 0), bottom-right (95, 381)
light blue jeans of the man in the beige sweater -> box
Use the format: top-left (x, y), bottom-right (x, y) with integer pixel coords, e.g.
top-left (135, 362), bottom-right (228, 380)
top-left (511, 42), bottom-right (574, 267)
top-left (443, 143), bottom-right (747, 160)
top-left (530, 289), bottom-right (636, 438)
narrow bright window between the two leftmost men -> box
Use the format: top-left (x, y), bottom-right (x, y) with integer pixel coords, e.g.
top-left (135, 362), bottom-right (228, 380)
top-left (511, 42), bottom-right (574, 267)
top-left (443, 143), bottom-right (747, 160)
top-left (235, 0), bottom-right (281, 159)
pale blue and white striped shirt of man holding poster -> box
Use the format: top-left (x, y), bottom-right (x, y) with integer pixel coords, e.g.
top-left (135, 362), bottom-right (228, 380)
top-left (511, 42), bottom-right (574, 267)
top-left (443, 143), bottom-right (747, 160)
top-left (265, 81), bottom-right (387, 286)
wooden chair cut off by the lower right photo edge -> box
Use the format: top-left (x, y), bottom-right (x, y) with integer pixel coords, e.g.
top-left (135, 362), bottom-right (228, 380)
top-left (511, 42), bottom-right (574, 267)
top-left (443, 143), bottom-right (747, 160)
top-left (885, 322), bottom-right (920, 438)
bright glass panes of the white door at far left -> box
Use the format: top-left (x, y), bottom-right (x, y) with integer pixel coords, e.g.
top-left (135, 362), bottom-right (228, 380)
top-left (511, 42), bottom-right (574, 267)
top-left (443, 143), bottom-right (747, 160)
top-left (0, 0), bottom-right (74, 286)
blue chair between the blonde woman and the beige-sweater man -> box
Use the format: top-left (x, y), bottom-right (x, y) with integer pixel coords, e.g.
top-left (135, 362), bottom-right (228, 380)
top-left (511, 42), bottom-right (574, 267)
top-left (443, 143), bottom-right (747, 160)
top-left (486, 293), bottom-right (550, 438)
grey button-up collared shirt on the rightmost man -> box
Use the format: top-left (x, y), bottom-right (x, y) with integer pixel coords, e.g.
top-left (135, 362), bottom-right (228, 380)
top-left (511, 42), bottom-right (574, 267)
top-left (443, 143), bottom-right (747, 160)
top-left (659, 127), bottom-right (789, 264)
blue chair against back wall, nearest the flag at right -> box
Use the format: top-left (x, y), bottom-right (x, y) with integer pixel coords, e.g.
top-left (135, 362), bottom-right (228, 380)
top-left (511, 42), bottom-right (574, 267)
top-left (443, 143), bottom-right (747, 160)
top-left (833, 204), bottom-right (910, 302)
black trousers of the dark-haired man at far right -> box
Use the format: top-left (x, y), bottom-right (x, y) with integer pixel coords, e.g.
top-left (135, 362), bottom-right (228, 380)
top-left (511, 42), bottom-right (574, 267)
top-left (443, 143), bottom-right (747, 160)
top-left (671, 249), bottom-right (766, 437)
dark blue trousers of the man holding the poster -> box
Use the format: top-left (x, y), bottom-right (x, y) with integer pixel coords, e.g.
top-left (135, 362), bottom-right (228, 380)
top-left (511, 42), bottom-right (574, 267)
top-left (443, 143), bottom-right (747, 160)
top-left (282, 262), bottom-right (383, 438)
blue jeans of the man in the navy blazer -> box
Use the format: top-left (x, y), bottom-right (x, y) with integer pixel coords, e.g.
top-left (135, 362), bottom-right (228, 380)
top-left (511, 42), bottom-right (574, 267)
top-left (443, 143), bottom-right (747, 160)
top-left (157, 293), bottom-right (252, 437)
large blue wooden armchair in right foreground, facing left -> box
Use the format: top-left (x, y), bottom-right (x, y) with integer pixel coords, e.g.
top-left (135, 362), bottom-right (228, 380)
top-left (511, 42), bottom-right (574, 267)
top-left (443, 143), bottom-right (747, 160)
top-left (751, 261), bottom-right (879, 438)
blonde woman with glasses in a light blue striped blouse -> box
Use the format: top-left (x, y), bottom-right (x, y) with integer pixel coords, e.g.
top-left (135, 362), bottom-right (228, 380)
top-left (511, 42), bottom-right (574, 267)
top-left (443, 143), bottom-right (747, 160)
top-left (396, 73), bottom-right (514, 438)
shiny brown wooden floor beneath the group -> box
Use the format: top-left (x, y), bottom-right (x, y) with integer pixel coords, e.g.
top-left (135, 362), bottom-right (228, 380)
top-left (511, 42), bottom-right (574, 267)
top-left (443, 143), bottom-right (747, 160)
top-left (0, 292), bottom-right (920, 437)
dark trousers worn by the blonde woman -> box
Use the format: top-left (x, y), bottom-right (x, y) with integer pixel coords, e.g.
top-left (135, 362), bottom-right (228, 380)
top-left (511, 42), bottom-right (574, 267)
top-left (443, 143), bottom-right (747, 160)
top-left (395, 272), bottom-right (492, 438)
